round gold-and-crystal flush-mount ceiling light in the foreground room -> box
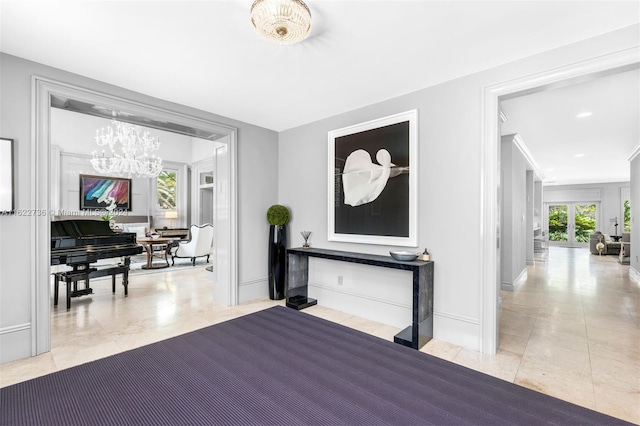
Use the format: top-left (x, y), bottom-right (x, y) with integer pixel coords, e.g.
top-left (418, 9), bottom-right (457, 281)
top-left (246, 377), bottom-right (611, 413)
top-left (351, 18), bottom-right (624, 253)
top-left (251, 0), bottom-right (311, 44)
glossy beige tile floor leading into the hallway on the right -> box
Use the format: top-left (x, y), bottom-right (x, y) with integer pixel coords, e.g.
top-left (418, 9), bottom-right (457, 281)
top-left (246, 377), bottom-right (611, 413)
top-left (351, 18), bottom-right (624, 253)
top-left (423, 247), bottom-right (640, 423)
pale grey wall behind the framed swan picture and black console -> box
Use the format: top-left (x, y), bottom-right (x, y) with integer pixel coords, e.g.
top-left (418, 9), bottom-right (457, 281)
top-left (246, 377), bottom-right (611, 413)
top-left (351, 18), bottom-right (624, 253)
top-left (278, 26), bottom-right (639, 350)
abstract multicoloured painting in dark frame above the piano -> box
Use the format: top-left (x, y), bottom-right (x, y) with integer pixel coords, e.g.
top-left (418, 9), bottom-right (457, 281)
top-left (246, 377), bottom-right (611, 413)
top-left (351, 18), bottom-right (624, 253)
top-left (80, 175), bottom-right (131, 211)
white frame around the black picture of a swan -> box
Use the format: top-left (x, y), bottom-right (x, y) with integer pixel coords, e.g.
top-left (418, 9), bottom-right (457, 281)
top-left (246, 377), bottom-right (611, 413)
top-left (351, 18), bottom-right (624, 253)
top-left (327, 109), bottom-right (419, 247)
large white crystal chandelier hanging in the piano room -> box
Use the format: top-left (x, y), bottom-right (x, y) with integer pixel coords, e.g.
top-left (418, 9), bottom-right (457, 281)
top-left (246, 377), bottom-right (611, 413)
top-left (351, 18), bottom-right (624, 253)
top-left (91, 120), bottom-right (162, 178)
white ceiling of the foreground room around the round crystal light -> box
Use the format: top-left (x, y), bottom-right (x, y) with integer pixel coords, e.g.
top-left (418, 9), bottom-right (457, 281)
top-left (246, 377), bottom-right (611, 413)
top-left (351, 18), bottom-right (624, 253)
top-left (0, 0), bottom-right (640, 131)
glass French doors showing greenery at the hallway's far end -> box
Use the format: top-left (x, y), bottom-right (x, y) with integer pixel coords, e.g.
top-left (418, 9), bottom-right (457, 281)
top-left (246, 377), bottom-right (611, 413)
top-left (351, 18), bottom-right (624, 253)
top-left (544, 202), bottom-right (600, 247)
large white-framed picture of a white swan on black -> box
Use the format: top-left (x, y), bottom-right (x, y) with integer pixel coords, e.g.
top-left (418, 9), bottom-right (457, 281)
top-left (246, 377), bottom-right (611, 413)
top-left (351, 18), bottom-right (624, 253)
top-left (328, 110), bottom-right (418, 247)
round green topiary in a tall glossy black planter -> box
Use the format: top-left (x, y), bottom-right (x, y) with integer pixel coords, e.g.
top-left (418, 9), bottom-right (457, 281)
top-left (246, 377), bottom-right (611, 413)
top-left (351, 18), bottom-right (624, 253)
top-left (267, 204), bottom-right (290, 300)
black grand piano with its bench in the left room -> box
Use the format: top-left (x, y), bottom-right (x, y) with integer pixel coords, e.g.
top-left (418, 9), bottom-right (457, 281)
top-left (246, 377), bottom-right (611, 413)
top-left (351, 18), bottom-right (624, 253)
top-left (51, 219), bottom-right (142, 310)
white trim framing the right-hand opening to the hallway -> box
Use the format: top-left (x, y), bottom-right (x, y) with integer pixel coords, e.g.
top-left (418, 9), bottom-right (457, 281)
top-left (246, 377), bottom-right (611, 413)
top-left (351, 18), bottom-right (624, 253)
top-left (479, 47), bottom-right (640, 354)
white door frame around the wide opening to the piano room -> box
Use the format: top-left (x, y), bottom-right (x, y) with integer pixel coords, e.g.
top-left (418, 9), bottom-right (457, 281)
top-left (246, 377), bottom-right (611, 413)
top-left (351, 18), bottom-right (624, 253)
top-left (28, 75), bottom-right (238, 356)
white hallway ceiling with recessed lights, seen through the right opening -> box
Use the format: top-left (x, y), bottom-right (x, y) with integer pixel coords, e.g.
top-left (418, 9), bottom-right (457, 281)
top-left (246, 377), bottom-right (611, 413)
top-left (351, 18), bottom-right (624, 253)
top-left (501, 69), bottom-right (640, 185)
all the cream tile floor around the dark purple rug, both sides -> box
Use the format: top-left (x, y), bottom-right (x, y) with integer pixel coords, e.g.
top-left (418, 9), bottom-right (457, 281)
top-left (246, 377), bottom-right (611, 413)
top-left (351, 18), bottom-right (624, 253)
top-left (0, 248), bottom-right (640, 424)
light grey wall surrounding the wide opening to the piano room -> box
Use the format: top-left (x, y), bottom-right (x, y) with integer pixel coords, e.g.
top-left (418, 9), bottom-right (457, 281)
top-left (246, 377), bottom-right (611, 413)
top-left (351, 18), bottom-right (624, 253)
top-left (0, 54), bottom-right (278, 362)
